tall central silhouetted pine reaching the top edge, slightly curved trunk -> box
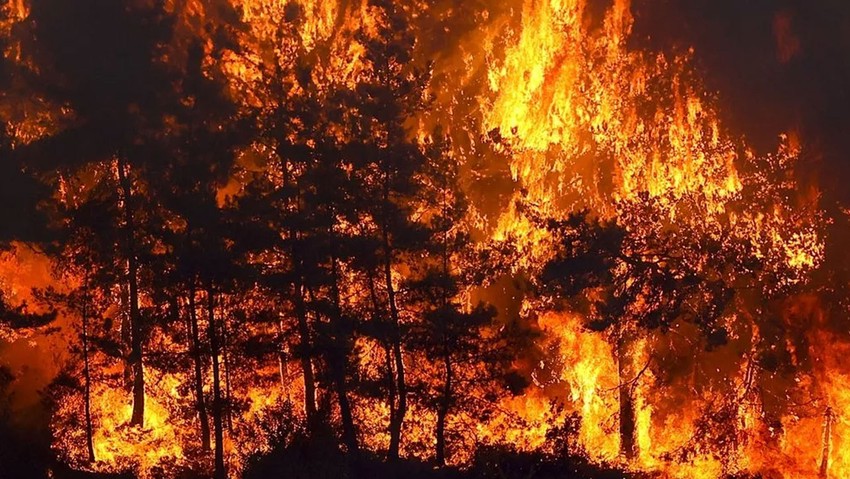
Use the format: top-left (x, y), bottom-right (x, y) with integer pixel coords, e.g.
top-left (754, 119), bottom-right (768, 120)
top-left (334, 1), bottom-right (430, 459)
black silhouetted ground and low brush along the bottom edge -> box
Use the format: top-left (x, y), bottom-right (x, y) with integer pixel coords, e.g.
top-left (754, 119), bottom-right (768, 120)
top-left (0, 408), bottom-right (640, 479)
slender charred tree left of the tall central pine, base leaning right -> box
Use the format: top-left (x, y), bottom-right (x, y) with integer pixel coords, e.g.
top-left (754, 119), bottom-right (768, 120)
top-left (238, 25), bottom-right (326, 435)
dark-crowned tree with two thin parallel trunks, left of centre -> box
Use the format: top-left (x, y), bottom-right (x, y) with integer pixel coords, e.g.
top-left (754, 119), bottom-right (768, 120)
top-left (150, 27), bottom-right (245, 478)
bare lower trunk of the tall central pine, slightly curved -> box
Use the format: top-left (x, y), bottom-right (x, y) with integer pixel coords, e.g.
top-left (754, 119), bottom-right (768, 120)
top-left (383, 229), bottom-right (407, 460)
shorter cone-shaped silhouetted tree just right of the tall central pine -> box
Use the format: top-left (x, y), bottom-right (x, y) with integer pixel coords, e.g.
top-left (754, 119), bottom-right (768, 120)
top-left (404, 129), bottom-right (524, 466)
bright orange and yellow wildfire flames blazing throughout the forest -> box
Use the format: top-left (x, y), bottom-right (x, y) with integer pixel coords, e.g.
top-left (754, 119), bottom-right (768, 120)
top-left (0, 0), bottom-right (836, 479)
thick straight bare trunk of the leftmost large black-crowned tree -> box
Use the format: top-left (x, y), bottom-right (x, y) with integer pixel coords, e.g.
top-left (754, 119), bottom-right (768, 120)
top-left (118, 155), bottom-right (145, 426)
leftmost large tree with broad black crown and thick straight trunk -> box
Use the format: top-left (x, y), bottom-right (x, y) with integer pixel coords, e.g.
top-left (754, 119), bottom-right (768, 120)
top-left (18, 0), bottom-right (177, 425)
